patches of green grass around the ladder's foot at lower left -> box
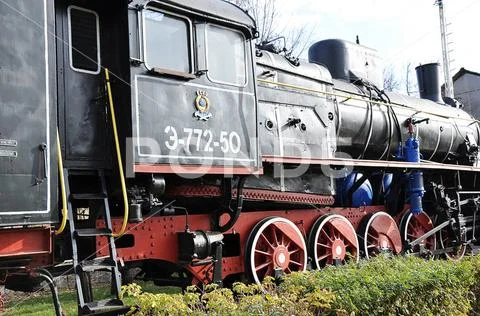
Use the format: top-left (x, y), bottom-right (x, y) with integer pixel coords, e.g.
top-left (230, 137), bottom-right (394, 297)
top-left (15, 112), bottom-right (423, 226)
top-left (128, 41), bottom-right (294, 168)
top-left (2, 282), bottom-right (181, 316)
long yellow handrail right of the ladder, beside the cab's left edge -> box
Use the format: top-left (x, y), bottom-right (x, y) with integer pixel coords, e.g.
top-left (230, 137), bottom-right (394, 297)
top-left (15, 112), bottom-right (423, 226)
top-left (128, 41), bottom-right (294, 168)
top-left (105, 68), bottom-right (129, 237)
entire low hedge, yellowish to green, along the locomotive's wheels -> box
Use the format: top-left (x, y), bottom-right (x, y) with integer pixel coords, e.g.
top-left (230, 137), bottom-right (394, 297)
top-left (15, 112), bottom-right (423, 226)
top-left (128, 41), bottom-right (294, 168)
top-left (123, 257), bottom-right (480, 316)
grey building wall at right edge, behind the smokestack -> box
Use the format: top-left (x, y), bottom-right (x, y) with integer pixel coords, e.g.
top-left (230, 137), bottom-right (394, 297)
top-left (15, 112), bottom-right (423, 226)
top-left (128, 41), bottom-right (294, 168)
top-left (453, 73), bottom-right (480, 119)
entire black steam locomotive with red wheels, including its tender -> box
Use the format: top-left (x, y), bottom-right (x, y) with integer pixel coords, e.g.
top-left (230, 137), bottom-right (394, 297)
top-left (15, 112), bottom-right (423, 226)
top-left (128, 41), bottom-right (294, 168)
top-left (0, 0), bottom-right (480, 314)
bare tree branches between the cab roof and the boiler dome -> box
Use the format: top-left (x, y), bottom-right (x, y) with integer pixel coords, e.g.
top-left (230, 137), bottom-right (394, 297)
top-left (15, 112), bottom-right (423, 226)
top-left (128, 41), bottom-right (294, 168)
top-left (226, 0), bottom-right (313, 57)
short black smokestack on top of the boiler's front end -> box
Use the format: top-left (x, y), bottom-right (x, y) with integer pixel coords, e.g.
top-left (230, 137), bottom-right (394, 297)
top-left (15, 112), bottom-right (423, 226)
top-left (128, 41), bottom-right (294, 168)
top-left (415, 63), bottom-right (442, 103)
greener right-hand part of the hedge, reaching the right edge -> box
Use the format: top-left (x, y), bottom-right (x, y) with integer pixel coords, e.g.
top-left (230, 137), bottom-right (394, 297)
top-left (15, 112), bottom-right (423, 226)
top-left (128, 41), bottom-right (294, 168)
top-left (282, 257), bottom-right (480, 315)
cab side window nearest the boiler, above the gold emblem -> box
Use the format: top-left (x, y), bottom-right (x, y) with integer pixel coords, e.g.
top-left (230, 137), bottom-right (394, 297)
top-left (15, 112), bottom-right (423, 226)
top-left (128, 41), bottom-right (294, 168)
top-left (206, 24), bottom-right (247, 86)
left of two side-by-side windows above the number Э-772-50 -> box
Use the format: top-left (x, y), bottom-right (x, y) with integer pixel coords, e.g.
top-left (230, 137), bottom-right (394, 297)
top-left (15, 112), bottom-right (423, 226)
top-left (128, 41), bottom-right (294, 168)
top-left (144, 10), bottom-right (193, 73)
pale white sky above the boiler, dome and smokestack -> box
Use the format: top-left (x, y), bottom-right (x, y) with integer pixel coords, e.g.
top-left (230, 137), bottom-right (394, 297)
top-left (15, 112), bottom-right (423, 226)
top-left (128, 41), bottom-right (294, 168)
top-left (276, 0), bottom-right (480, 86)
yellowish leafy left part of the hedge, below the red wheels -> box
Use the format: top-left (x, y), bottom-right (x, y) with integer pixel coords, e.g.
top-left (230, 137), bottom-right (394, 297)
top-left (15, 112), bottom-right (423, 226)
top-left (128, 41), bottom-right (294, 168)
top-left (122, 278), bottom-right (335, 316)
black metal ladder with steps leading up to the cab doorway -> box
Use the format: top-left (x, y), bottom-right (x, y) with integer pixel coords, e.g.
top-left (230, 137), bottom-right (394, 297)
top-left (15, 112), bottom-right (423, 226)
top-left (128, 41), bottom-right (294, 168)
top-left (63, 168), bottom-right (130, 315)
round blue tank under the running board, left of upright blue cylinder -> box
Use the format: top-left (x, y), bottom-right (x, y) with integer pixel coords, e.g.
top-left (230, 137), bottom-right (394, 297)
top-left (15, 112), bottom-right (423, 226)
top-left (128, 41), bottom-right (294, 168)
top-left (337, 173), bottom-right (373, 207)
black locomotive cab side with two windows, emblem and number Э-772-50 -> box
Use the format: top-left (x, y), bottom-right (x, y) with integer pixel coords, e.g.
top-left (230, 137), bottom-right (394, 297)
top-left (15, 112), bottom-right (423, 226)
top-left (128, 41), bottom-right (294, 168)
top-left (125, 1), bottom-right (260, 175)
